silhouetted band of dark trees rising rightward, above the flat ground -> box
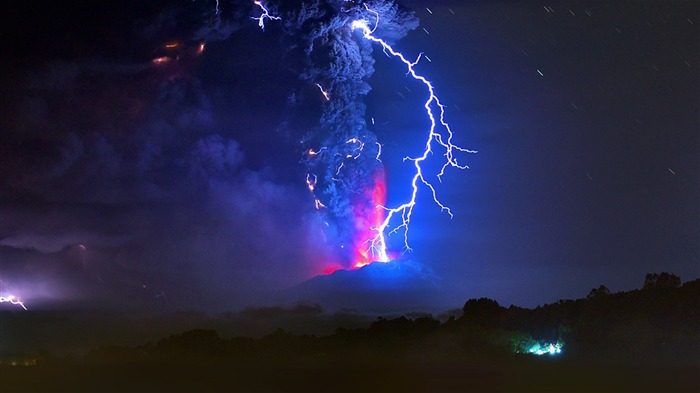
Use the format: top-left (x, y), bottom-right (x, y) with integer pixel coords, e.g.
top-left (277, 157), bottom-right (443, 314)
top-left (80, 273), bottom-right (700, 363)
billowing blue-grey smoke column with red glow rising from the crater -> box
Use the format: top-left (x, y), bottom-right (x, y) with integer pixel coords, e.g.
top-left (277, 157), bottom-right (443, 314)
top-left (283, 1), bottom-right (418, 267)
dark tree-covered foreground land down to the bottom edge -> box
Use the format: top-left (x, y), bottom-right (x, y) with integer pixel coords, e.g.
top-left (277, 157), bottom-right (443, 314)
top-left (0, 273), bottom-right (700, 392)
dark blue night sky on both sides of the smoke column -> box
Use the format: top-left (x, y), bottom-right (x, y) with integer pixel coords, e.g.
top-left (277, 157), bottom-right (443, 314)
top-left (0, 0), bottom-right (700, 310)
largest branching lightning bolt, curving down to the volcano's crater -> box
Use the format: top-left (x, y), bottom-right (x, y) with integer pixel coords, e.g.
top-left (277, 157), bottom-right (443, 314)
top-left (350, 4), bottom-right (476, 262)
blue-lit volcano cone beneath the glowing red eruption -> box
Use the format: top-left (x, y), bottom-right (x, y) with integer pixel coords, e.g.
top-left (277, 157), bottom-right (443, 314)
top-left (283, 260), bottom-right (444, 312)
